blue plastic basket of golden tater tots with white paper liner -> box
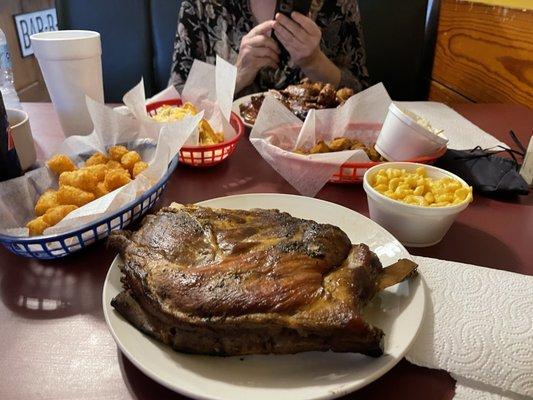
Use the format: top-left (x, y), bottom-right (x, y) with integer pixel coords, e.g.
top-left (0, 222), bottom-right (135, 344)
top-left (0, 94), bottom-right (199, 259)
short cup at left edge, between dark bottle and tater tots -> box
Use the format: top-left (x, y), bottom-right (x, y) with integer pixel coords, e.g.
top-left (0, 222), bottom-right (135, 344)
top-left (6, 108), bottom-right (37, 171)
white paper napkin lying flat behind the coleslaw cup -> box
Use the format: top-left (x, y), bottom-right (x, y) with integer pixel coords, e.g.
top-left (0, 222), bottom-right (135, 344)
top-left (396, 101), bottom-right (509, 150)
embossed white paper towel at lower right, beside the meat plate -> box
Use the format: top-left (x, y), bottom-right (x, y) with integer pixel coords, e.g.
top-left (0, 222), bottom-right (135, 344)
top-left (406, 257), bottom-right (533, 400)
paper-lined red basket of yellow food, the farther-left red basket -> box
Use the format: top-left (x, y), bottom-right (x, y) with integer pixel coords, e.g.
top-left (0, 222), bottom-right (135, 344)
top-left (119, 58), bottom-right (245, 167)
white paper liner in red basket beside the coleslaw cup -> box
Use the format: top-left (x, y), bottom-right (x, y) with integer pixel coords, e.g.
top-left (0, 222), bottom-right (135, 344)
top-left (250, 83), bottom-right (391, 196)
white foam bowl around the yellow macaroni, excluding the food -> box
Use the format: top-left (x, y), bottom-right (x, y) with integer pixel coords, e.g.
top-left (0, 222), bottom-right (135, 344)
top-left (363, 162), bottom-right (469, 247)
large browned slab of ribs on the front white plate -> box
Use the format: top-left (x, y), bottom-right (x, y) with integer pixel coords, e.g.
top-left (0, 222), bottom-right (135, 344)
top-left (109, 203), bottom-right (416, 356)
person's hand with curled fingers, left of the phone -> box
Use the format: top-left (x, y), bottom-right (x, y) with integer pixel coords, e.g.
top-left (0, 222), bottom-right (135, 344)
top-left (236, 21), bottom-right (280, 92)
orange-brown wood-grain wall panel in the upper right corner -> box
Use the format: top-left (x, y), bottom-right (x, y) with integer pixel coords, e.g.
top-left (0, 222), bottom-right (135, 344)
top-left (430, 0), bottom-right (533, 107)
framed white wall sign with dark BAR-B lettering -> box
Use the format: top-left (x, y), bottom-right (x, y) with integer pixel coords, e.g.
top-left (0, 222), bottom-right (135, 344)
top-left (13, 8), bottom-right (57, 57)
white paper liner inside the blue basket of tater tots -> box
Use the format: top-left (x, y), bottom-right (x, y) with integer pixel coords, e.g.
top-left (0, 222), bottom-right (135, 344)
top-left (0, 96), bottom-right (203, 236)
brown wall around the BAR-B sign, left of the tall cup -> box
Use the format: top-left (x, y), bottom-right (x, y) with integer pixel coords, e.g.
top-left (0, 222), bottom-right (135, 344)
top-left (0, 0), bottom-right (54, 101)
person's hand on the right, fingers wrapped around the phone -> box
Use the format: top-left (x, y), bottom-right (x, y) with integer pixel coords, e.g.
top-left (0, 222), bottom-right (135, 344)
top-left (274, 12), bottom-right (322, 67)
